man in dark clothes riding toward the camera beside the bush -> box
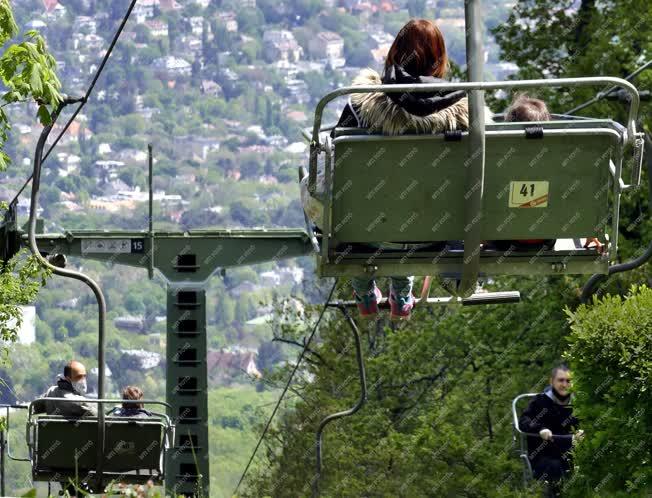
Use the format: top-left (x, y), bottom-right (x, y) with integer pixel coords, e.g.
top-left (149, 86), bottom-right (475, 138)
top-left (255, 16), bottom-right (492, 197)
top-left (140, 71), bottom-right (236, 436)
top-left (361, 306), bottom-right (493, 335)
top-left (519, 364), bottom-right (583, 497)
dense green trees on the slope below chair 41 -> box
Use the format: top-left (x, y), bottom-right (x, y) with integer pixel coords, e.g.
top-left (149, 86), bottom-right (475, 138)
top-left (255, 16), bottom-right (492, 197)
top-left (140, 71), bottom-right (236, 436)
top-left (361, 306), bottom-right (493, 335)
top-left (244, 278), bottom-right (576, 498)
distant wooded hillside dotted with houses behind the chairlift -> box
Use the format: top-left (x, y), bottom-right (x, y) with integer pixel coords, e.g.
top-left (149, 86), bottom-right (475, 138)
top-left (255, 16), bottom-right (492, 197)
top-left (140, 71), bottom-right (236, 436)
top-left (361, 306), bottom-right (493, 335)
top-left (0, 0), bottom-right (517, 496)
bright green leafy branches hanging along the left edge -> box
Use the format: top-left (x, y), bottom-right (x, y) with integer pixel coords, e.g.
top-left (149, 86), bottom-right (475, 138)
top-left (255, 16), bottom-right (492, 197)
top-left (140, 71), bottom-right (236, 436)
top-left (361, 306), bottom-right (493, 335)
top-left (0, 0), bottom-right (61, 340)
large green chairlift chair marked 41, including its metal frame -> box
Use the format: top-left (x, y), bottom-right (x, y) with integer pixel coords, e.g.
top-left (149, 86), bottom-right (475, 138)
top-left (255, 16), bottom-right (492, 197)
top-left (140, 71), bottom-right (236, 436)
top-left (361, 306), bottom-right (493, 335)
top-left (304, 77), bottom-right (643, 304)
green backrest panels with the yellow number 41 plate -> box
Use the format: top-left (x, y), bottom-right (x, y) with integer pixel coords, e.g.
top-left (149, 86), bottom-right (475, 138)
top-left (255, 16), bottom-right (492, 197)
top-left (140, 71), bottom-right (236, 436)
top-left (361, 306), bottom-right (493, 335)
top-left (327, 120), bottom-right (622, 243)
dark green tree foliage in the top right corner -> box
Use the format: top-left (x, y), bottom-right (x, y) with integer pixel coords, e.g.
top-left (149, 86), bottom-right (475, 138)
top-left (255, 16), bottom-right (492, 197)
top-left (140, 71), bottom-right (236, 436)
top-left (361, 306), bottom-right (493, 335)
top-left (492, 0), bottom-right (652, 112)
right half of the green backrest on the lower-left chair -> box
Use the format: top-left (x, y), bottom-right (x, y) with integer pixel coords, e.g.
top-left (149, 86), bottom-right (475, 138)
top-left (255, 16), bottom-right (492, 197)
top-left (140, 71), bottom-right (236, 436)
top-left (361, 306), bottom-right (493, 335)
top-left (104, 417), bottom-right (165, 472)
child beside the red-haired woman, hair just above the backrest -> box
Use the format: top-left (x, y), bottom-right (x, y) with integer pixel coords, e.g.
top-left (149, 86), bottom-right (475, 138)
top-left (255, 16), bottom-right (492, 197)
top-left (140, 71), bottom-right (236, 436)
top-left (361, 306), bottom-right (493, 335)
top-left (491, 93), bottom-right (602, 252)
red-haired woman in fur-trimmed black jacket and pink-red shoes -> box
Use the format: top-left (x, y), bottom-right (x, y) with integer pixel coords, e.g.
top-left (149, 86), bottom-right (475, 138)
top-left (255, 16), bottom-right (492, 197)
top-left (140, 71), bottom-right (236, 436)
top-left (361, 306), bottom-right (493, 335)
top-left (301, 19), bottom-right (492, 319)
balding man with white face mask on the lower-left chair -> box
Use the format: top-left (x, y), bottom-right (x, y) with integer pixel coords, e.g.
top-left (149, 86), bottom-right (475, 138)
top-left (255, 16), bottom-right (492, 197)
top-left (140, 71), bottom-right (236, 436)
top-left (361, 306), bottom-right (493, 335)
top-left (42, 360), bottom-right (97, 417)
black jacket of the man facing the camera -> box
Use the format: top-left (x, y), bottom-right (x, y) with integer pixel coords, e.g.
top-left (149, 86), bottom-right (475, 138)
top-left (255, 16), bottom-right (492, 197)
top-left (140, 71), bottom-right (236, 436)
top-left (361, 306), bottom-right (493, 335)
top-left (518, 388), bottom-right (579, 463)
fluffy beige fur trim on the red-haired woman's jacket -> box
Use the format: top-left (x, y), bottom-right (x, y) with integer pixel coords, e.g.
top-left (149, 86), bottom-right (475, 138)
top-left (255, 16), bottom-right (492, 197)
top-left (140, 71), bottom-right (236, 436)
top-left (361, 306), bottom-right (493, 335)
top-left (351, 68), bottom-right (493, 135)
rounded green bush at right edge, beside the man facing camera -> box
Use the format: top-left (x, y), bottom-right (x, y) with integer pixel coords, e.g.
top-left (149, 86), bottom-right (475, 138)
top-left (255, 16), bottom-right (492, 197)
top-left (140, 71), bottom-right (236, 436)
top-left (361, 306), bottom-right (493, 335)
top-left (567, 287), bottom-right (652, 498)
